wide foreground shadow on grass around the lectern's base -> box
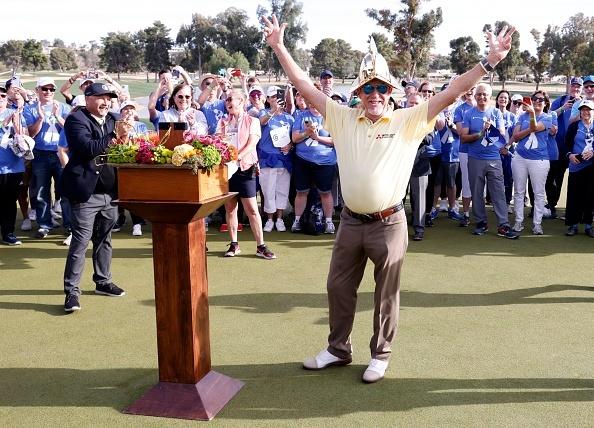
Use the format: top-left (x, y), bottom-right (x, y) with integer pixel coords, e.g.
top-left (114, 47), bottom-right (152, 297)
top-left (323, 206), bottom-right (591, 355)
top-left (0, 363), bottom-right (594, 420)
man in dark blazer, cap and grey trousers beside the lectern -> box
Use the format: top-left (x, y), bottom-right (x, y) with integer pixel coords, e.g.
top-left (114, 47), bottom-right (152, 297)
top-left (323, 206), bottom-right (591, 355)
top-left (60, 83), bottom-right (126, 312)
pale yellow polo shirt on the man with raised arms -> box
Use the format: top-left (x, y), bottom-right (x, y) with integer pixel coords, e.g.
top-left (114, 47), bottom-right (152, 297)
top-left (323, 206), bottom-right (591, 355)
top-left (324, 98), bottom-right (435, 213)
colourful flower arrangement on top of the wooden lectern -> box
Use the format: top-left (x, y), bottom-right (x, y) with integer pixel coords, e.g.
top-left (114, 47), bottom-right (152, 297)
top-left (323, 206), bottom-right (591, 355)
top-left (107, 131), bottom-right (237, 174)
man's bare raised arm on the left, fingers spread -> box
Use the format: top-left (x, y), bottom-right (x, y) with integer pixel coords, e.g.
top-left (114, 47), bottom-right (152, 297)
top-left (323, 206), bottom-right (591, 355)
top-left (262, 15), bottom-right (327, 116)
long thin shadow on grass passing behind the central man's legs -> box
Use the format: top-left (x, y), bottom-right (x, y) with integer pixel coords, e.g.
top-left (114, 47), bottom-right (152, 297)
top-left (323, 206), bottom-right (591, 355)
top-left (199, 284), bottom-right (594, 313)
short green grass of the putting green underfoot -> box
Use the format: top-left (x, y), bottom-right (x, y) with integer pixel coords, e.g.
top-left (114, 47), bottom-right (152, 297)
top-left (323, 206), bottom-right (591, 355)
top-left (0, 203), bottom-right (594, 427)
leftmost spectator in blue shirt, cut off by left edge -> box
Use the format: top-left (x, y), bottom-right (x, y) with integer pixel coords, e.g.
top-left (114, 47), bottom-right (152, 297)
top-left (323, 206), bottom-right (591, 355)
top-left (0, 87), bottom-right (25, 245)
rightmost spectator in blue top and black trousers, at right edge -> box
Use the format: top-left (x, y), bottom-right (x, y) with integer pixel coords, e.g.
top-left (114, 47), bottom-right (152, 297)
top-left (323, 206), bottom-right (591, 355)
top-left (565, 100), bottom-right (594, 238)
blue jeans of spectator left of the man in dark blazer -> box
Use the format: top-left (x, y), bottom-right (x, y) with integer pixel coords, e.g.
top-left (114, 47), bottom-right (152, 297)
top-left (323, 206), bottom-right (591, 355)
top-left (31, 150), bottom-right (62, 230)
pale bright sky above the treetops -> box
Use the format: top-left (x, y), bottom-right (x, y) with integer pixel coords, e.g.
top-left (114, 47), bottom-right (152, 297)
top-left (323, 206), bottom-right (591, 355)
top-left (0, 0), bottom-right (584, 55)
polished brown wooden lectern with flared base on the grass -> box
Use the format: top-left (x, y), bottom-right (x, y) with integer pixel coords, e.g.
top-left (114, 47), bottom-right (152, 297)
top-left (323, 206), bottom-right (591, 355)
top-left (117, 165), bottom-right (243, 420)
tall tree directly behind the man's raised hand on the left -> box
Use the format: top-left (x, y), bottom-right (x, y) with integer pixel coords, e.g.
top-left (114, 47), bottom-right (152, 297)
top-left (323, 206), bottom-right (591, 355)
top-left (256, 0), bottom-right (307, 76)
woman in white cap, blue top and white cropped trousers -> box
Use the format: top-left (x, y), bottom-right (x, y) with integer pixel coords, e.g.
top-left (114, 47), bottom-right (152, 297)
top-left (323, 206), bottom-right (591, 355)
top-left (257, 86), bottom-right (294, 232)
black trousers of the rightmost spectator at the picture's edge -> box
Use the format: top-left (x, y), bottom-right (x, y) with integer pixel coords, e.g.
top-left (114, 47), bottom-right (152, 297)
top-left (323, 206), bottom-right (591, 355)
top-left (565, 166), bottom-right (594, 226)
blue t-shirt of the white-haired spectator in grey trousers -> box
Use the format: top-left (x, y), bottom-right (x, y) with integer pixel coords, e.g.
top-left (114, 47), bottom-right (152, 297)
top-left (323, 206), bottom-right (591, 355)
top-left (462, 107), bottom-right (504, 160)
